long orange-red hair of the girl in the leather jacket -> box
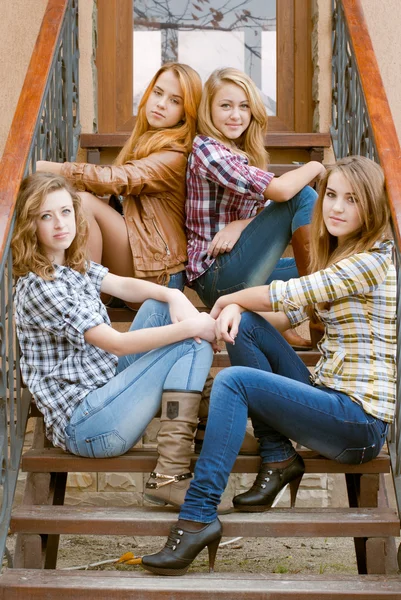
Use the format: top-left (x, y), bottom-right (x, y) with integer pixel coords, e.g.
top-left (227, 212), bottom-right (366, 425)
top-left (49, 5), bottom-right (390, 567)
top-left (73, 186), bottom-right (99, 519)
top-left (115, 62), bottom-right (202, 165)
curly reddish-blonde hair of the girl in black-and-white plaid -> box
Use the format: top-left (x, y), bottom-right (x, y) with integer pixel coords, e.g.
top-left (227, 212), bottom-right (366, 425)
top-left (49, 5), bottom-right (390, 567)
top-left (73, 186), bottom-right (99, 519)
top-left (11, 173), bottom-right (88, 281)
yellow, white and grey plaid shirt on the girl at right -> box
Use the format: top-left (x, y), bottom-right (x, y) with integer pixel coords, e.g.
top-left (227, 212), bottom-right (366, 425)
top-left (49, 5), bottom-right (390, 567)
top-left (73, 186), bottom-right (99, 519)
top-left (269, 241), bottom-right (396, 423)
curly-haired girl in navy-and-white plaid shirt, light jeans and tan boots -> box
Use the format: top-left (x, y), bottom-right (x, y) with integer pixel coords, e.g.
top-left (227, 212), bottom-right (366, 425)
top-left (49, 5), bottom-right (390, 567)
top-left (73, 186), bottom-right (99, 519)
top-left (12, 173), bottom-right (215, 505)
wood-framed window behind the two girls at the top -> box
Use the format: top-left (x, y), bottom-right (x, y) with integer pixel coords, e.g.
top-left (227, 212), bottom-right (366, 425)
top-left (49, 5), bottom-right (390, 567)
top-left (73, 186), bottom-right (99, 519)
top-left (97, 0), bottom-right (312, 133)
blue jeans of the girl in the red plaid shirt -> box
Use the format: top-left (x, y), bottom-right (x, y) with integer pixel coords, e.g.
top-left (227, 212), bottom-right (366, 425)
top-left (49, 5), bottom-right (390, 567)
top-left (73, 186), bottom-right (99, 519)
top-left (193, 186), bottom-right (317, 308)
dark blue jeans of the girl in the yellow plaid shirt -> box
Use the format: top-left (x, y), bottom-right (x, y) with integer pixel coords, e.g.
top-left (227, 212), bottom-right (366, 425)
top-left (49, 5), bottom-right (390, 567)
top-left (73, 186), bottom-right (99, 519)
top-left (180, 313), bottom-right (388, 523)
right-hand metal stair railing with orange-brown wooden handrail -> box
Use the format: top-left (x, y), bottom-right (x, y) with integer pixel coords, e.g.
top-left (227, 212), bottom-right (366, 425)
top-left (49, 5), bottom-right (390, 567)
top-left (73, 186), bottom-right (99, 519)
top-left (331, 0), bottom-right (401, 516)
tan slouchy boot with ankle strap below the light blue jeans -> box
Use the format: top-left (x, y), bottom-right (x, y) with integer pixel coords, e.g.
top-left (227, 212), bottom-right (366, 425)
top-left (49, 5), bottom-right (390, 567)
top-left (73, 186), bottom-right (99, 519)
top-left (145, 390), bottom-right (201, 507)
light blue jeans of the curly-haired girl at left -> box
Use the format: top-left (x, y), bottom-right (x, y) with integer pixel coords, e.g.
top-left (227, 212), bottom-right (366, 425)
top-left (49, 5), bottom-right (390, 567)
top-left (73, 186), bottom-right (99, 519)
top-left (65, 300), bottom-right (213, 458)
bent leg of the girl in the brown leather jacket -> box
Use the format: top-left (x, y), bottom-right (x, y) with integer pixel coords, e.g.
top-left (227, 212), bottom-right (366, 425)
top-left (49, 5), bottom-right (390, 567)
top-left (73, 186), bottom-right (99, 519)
top-left (79, 192), bottom-right (134, 277)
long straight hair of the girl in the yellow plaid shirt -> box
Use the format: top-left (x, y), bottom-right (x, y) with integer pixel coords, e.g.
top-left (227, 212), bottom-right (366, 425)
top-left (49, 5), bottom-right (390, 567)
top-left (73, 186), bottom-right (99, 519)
top-left (310, 156), bottom-right (391, 273)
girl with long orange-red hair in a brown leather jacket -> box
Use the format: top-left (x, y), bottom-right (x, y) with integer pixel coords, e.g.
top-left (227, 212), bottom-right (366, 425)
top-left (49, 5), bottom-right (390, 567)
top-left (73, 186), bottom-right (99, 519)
top-left (36, 63), bottom-right (202, 289)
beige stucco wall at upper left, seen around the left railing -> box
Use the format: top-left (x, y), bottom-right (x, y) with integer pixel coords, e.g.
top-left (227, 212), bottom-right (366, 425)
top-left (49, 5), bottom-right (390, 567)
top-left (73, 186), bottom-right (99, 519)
top-left (0, 0), bottom-right (95, 161)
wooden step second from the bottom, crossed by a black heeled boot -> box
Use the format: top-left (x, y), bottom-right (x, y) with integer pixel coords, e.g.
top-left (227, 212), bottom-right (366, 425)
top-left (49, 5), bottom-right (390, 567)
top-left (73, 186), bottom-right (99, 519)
top-left (10, 505), bottom-right (400, 537)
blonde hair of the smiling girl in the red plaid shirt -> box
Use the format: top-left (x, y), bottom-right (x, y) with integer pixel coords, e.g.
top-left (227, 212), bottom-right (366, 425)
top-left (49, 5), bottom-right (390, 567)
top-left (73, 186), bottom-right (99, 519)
top-left (198, 67), bottom-right (269, 169)
